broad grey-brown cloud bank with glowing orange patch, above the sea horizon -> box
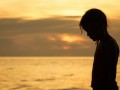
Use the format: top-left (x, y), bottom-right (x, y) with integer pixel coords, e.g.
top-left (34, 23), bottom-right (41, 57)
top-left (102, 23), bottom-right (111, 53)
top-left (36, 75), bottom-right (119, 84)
top-left (0, 16), bottom-right (120, 56)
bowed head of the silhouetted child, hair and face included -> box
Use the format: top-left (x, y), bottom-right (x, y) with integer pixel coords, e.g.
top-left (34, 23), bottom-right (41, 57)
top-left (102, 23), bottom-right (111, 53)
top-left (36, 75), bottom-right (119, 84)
top-left (79, 9), bottom-right (107, 41)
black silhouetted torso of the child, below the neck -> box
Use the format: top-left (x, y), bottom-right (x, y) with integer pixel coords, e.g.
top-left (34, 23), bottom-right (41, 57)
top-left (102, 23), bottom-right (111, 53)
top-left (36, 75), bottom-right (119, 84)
top-left (91, 38), bottom-right (119, 87)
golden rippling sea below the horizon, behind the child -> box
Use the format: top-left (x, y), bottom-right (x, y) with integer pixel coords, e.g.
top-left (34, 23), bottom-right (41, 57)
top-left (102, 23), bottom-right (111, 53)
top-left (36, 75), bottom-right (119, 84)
top-left (0, 57), bottom-right (120, 90)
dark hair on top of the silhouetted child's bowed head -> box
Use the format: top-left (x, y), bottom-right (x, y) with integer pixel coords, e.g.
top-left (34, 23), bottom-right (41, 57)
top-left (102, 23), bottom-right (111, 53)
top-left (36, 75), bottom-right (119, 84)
top-left (79, 8), bottom-right (107, 32)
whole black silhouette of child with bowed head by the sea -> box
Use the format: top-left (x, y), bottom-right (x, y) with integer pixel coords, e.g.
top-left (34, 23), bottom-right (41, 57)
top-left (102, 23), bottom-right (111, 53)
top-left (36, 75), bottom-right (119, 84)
top-left (79, 8), bottom-right (119, 90)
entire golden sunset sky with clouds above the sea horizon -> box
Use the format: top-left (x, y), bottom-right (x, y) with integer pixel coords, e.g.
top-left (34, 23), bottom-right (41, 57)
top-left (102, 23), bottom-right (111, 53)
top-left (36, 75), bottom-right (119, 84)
top-left (0, 0), bottom-right (120, 56)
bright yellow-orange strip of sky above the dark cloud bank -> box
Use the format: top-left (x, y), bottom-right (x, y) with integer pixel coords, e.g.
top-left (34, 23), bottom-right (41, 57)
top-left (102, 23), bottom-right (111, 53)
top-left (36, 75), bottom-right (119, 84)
top-left (0, 0), bottom-right (120, 19)
